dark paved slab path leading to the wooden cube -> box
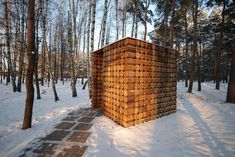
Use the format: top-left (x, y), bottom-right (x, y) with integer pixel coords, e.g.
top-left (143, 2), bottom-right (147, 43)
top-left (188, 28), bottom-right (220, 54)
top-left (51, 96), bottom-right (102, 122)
top-left (21, 108), bottom-right (102, 157)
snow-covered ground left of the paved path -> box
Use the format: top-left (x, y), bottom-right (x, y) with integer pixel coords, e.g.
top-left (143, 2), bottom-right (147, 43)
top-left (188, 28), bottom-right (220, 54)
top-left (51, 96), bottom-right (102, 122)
top-left (0, 79), bottom-right (90, 156)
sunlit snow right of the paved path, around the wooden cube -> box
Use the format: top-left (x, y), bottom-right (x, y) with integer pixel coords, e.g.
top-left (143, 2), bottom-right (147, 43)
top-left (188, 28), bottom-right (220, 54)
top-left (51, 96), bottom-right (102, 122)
top-left (84, 82), bottom-right (235, 157)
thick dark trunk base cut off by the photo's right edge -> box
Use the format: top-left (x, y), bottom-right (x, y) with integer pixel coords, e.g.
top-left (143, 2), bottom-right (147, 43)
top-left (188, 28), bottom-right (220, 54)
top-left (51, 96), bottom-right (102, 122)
top-left (226, 48), bottom-right (235, 103)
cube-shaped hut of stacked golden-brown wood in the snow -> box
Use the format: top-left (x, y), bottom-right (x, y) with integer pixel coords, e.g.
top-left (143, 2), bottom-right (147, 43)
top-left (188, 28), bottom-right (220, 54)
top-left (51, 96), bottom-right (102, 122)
top-left (92, 37), bottom-right (176, 127)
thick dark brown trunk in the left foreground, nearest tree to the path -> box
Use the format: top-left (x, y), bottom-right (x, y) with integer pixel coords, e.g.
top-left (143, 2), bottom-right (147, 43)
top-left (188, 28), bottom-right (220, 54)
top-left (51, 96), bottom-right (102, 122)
top-left (22, 0), bottom-right (35, 129)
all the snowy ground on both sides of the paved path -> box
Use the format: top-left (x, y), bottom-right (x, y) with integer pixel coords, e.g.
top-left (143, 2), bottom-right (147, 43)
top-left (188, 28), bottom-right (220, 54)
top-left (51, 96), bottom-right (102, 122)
top-left (0, 82), bottom-right (235, 157)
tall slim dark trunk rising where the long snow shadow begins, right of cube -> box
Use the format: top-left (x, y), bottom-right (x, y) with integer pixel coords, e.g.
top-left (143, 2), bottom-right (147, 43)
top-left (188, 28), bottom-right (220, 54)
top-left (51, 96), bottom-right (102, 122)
top-left (188, 0), bottom-right (198, 93)
